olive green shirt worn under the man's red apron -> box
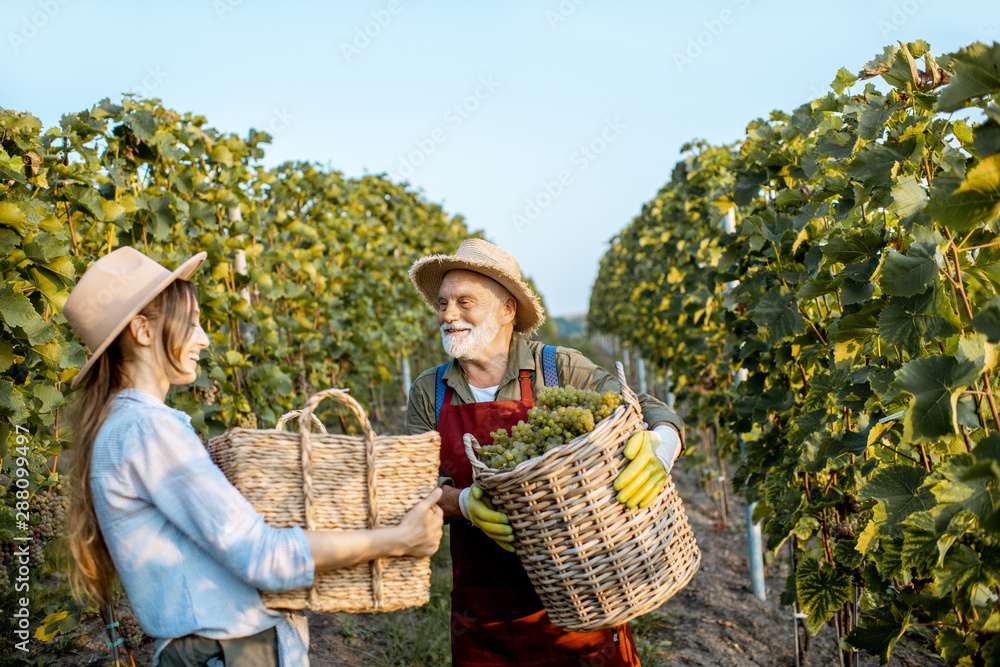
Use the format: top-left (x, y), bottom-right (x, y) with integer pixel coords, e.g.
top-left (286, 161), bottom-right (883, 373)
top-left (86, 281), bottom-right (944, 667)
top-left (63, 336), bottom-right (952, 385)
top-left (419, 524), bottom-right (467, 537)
top-left (406, 333), bottom-right (684, 443)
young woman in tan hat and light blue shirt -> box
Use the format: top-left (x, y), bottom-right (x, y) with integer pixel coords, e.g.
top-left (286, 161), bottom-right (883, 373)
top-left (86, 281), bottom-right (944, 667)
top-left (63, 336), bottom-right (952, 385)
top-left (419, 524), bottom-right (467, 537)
top-left (63, 247), bottom-right (442, 667)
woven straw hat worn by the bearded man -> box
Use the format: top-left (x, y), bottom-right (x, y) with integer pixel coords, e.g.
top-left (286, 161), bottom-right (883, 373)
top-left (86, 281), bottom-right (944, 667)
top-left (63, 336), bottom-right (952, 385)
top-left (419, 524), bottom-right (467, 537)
top-left (410, 239), bottom-right (545, 335)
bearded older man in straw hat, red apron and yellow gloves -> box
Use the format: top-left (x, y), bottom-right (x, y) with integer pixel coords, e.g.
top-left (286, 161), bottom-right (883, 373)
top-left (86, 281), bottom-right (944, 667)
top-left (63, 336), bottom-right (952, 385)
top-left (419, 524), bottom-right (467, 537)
top-left (406, 239), bottom-right (683, 667)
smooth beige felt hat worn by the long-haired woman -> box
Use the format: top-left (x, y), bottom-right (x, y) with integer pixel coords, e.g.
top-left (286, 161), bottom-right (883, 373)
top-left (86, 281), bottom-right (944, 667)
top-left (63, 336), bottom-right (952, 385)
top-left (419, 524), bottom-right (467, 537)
top-left (63, 246), bottom-right (208, 389)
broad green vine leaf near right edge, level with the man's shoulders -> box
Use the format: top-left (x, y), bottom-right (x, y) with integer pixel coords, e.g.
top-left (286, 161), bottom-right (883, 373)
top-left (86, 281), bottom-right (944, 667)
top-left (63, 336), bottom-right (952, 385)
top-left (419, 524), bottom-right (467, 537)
top-left (893, 355), bottom-right (980, 443)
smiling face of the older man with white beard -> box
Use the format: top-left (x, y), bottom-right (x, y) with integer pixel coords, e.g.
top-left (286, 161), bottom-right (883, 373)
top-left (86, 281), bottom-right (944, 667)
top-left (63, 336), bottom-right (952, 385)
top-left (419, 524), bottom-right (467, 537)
top-left (438, 271), bottom-right (503, 359)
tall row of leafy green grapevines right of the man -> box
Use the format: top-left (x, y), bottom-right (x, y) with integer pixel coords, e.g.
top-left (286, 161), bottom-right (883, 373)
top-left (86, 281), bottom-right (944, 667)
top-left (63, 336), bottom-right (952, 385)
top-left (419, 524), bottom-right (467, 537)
top-left (588, 41), bottom-right (1000, 664)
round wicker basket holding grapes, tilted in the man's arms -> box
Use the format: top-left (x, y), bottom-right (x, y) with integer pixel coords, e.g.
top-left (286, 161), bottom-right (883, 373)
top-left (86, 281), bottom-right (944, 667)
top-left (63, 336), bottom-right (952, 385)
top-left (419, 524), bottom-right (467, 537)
top-left (465, 363), bottom-right (701, 632)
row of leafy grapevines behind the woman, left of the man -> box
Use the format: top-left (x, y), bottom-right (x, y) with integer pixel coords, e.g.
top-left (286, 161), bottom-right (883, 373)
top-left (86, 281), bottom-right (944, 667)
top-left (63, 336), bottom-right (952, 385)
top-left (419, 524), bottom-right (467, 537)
top-left (0, 96), bottom-right (469, 651)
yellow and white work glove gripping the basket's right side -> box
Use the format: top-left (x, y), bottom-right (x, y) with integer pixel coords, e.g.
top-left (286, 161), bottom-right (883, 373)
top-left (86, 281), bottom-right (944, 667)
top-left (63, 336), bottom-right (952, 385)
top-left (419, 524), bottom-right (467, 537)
top-left (614, 425), bottom-right (681, 509)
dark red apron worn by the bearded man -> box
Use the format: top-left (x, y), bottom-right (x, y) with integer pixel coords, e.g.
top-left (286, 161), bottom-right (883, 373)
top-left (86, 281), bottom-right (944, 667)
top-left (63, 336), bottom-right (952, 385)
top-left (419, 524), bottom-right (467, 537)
top-left (438, 370), bottom-right (639, 667)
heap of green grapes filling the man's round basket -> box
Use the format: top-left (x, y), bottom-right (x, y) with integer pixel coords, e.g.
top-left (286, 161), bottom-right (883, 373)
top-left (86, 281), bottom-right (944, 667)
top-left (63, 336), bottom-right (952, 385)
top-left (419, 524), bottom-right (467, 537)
top-left (480, 387), bottom-right (621, 469)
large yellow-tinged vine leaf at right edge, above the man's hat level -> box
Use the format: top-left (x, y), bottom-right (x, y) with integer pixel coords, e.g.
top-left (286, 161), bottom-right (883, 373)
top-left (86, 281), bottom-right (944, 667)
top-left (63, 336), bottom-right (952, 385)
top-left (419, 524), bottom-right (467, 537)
top-left (928, 153), bottom-right (1000, 233)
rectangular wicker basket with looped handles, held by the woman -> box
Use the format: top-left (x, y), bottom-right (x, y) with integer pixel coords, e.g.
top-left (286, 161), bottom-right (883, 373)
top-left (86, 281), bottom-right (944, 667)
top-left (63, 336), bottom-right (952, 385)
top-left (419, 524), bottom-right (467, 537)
top-left (208, 389), bottom-right (441, 612)
